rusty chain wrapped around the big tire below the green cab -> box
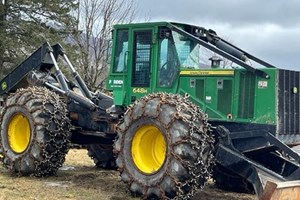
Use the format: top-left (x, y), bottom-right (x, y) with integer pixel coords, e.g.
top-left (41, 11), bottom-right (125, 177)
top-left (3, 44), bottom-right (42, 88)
top-left (114, 93), bottom-right (215, 200)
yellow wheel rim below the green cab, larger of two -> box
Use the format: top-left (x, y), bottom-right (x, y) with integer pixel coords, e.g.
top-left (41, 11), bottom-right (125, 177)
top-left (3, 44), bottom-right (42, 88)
top-left (131, 125), bottom-right (166, 174)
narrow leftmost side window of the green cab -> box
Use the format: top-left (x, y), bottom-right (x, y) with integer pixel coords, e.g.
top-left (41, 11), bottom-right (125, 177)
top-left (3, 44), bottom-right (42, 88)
top-left (113, 30), bottom-right (128, 72)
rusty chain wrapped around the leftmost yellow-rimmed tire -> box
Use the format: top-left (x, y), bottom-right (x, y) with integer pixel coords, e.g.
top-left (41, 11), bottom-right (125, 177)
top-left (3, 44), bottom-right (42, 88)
top-left (0, 87), bottom-right (72, 177)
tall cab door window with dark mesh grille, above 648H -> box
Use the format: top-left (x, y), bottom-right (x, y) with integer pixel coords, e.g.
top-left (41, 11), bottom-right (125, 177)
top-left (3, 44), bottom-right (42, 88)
top-left (132, 30), bottom-right (152, 87)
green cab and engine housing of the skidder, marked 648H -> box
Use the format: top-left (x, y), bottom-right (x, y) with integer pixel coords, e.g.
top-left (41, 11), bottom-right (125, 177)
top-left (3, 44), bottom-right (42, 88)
top-left (107, 22), bottom-right (275, 126)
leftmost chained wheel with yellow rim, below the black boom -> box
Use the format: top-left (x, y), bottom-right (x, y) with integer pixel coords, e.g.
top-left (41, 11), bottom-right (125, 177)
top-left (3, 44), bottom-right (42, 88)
top-left (0, 87), bottom-right (70, 177)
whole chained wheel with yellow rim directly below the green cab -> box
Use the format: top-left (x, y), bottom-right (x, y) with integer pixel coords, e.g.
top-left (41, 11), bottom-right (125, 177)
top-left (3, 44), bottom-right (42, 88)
top-left (114, 93), bottom-right (214, 199)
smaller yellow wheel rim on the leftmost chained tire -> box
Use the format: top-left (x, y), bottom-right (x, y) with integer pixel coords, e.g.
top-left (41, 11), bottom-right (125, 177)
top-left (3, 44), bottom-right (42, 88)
top-left (8, 113), bottom-right (30, 153)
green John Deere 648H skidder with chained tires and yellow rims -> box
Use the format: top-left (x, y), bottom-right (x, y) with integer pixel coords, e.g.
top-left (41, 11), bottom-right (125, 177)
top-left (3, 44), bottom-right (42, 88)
top-left (0, 22), bottom-right (300, 199)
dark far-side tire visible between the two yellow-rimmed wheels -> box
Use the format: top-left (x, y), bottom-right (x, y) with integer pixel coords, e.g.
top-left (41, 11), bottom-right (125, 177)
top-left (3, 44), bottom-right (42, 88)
top-left (87, 144), bottom-right (117, 169)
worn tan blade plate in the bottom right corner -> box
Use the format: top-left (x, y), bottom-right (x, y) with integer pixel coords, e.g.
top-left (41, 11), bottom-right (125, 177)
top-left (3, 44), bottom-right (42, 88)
top-left (261, 181), bottom-right (300, 200)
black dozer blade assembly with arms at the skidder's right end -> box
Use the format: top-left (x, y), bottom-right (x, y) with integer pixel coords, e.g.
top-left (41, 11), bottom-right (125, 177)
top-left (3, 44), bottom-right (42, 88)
top-left (215, 126), bottom-right (300, 200)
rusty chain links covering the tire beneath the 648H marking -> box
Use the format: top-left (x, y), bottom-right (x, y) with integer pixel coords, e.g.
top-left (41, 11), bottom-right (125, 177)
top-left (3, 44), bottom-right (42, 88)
top-left (115, 93), bottom-right (214, 199)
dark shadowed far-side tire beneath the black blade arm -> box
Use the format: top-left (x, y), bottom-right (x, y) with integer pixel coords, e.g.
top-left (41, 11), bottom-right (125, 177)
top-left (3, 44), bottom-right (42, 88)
top-left (213, 163), bottom-right (254, 193)
